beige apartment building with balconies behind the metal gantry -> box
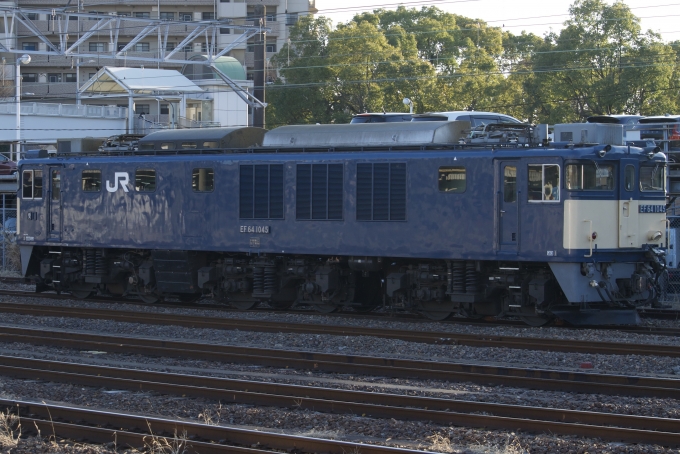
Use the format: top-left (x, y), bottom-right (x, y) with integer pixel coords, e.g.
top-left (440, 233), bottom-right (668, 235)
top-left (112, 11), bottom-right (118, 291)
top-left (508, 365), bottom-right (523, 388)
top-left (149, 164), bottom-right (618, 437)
top-left (7, 0), bottom-right (317, 124)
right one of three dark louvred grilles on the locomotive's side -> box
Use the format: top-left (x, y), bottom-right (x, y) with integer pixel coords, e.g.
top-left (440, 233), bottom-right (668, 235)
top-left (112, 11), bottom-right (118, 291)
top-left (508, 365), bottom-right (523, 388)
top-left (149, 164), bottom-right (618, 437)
top-left (356, 163), bottom-right (406, 221)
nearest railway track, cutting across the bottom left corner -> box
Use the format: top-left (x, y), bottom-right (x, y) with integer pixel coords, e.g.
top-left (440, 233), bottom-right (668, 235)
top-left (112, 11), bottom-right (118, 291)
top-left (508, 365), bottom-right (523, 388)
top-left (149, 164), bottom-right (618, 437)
top-left (0, 399), bottom-right (423, 454)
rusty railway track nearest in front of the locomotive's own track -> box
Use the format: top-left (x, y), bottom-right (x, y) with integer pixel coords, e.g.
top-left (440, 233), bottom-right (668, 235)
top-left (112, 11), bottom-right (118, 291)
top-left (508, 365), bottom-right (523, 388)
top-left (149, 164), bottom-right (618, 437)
top-left (0, 303), bottom-right (680, 358)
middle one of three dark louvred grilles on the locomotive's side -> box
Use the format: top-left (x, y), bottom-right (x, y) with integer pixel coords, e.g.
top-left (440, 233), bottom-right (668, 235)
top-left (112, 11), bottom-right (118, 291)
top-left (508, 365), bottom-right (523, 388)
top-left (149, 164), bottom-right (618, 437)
top-left (295, 164), bottom-right (343, 220)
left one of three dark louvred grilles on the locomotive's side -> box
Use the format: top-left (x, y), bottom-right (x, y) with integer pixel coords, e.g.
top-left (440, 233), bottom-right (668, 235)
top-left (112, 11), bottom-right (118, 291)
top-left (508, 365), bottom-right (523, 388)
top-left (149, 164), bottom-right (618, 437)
top-left (239, 164), bottom-right (283, 219)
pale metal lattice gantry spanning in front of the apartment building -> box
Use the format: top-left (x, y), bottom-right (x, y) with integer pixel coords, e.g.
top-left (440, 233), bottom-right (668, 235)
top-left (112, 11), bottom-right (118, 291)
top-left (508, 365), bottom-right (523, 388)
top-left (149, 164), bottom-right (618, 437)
top-left (0, 7), bottom-right (271, 109)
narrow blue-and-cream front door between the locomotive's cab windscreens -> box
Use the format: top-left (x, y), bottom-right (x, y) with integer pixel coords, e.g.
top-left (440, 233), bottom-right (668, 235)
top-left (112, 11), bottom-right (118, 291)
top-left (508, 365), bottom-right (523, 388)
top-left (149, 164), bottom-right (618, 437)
top-left (618, 159), bottom-right (640, 247)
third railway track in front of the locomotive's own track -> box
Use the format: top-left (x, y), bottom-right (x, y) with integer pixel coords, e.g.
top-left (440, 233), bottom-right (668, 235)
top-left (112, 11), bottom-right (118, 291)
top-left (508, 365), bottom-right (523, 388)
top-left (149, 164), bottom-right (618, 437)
top-left (0, 356), bottom-right (680, 446)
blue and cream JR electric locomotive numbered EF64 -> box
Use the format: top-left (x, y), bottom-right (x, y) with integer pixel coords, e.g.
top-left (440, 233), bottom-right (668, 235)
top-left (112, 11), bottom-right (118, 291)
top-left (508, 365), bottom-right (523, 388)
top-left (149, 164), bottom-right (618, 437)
top-left (18, 122), bottom-right (666, 325)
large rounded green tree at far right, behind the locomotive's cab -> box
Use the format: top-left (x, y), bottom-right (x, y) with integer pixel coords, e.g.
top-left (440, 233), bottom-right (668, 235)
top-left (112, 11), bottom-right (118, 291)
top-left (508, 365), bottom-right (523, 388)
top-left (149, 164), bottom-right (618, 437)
top-left (525, 0), bottom-right (674, 123)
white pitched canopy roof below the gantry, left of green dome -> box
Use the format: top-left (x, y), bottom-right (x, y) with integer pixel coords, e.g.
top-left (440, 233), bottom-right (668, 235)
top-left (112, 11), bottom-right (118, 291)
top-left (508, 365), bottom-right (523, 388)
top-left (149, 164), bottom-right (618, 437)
top-left (80, 66), bottom-right (204, 96)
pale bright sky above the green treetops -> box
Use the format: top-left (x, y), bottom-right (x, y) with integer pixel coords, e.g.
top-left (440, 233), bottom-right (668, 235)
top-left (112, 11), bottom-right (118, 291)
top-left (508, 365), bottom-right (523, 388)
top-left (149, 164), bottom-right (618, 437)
top-left (316, 0), bottom-right (680, 42)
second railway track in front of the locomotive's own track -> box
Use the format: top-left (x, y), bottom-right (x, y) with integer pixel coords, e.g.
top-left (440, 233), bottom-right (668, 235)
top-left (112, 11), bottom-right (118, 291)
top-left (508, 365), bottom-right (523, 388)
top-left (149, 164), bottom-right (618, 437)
top-left (0, 326), bottom-right (680, 399)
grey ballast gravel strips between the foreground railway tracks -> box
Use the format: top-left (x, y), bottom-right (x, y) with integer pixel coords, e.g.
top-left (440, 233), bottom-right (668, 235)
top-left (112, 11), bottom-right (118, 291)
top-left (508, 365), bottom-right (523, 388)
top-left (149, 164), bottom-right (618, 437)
top-left (0, 290), bottom-right (680, 454)
